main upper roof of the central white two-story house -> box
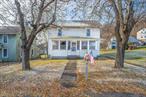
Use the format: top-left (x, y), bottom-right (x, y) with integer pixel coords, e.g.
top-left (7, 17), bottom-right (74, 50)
top-left (50, 20), bottom-right (101, 28)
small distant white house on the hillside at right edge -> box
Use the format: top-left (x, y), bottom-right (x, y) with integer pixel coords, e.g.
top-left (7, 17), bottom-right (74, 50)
top-left (137, 28), bottom-right (146, 42)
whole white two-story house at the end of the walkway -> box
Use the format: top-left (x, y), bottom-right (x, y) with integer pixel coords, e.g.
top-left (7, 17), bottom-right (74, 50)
top-left (48, 21), bottom-right (100, 58)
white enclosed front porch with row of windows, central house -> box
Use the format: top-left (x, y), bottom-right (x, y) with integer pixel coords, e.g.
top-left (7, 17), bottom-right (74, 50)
top-left (49, 37), bottom-right (99, 58)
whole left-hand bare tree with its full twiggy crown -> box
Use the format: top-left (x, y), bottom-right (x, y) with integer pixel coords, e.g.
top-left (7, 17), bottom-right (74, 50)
top-left (0, 0), bottom-right (57, 70)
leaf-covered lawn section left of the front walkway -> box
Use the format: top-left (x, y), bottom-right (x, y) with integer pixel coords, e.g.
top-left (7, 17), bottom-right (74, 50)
top-left (0, 60), bottom-right (68, 97)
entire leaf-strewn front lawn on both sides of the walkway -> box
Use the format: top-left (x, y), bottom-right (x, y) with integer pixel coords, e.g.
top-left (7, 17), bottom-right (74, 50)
top-left (0, 59), bottom-right (146, 97)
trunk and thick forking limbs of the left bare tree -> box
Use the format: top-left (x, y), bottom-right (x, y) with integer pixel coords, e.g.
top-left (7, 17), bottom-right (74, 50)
top-left (15, 0), bottom-right (57, 70)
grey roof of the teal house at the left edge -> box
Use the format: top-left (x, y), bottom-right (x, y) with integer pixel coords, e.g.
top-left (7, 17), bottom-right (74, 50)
top-left (0, 26), bottom-right (20, 34)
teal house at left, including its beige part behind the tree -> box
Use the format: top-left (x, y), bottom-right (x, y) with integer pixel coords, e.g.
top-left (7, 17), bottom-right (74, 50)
top-left (0, 26), bottom-right (40, 62)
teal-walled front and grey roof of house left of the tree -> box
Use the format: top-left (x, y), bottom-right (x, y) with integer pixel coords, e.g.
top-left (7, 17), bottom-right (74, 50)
top-left (0, 26), bottom-right (20, 62)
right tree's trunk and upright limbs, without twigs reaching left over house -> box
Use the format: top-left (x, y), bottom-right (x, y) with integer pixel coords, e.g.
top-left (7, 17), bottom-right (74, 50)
top-left (108, 0), bottom-right (146, 68)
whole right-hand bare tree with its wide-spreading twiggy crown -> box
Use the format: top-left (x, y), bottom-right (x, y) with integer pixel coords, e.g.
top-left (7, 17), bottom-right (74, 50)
top-left (74, 0), bottom-right (146, 68)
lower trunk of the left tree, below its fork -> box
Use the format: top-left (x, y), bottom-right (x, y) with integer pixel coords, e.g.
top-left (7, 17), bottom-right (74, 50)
top-left (22, 48), bottom-right (30, 70)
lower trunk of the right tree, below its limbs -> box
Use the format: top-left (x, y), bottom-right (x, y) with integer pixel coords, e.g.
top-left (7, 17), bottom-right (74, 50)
top-left (115, 42), bottom-right (126, 68)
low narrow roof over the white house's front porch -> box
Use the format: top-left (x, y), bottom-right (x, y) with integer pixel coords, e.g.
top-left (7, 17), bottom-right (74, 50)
top-left (50, 36), bottom-right (97, 39)
